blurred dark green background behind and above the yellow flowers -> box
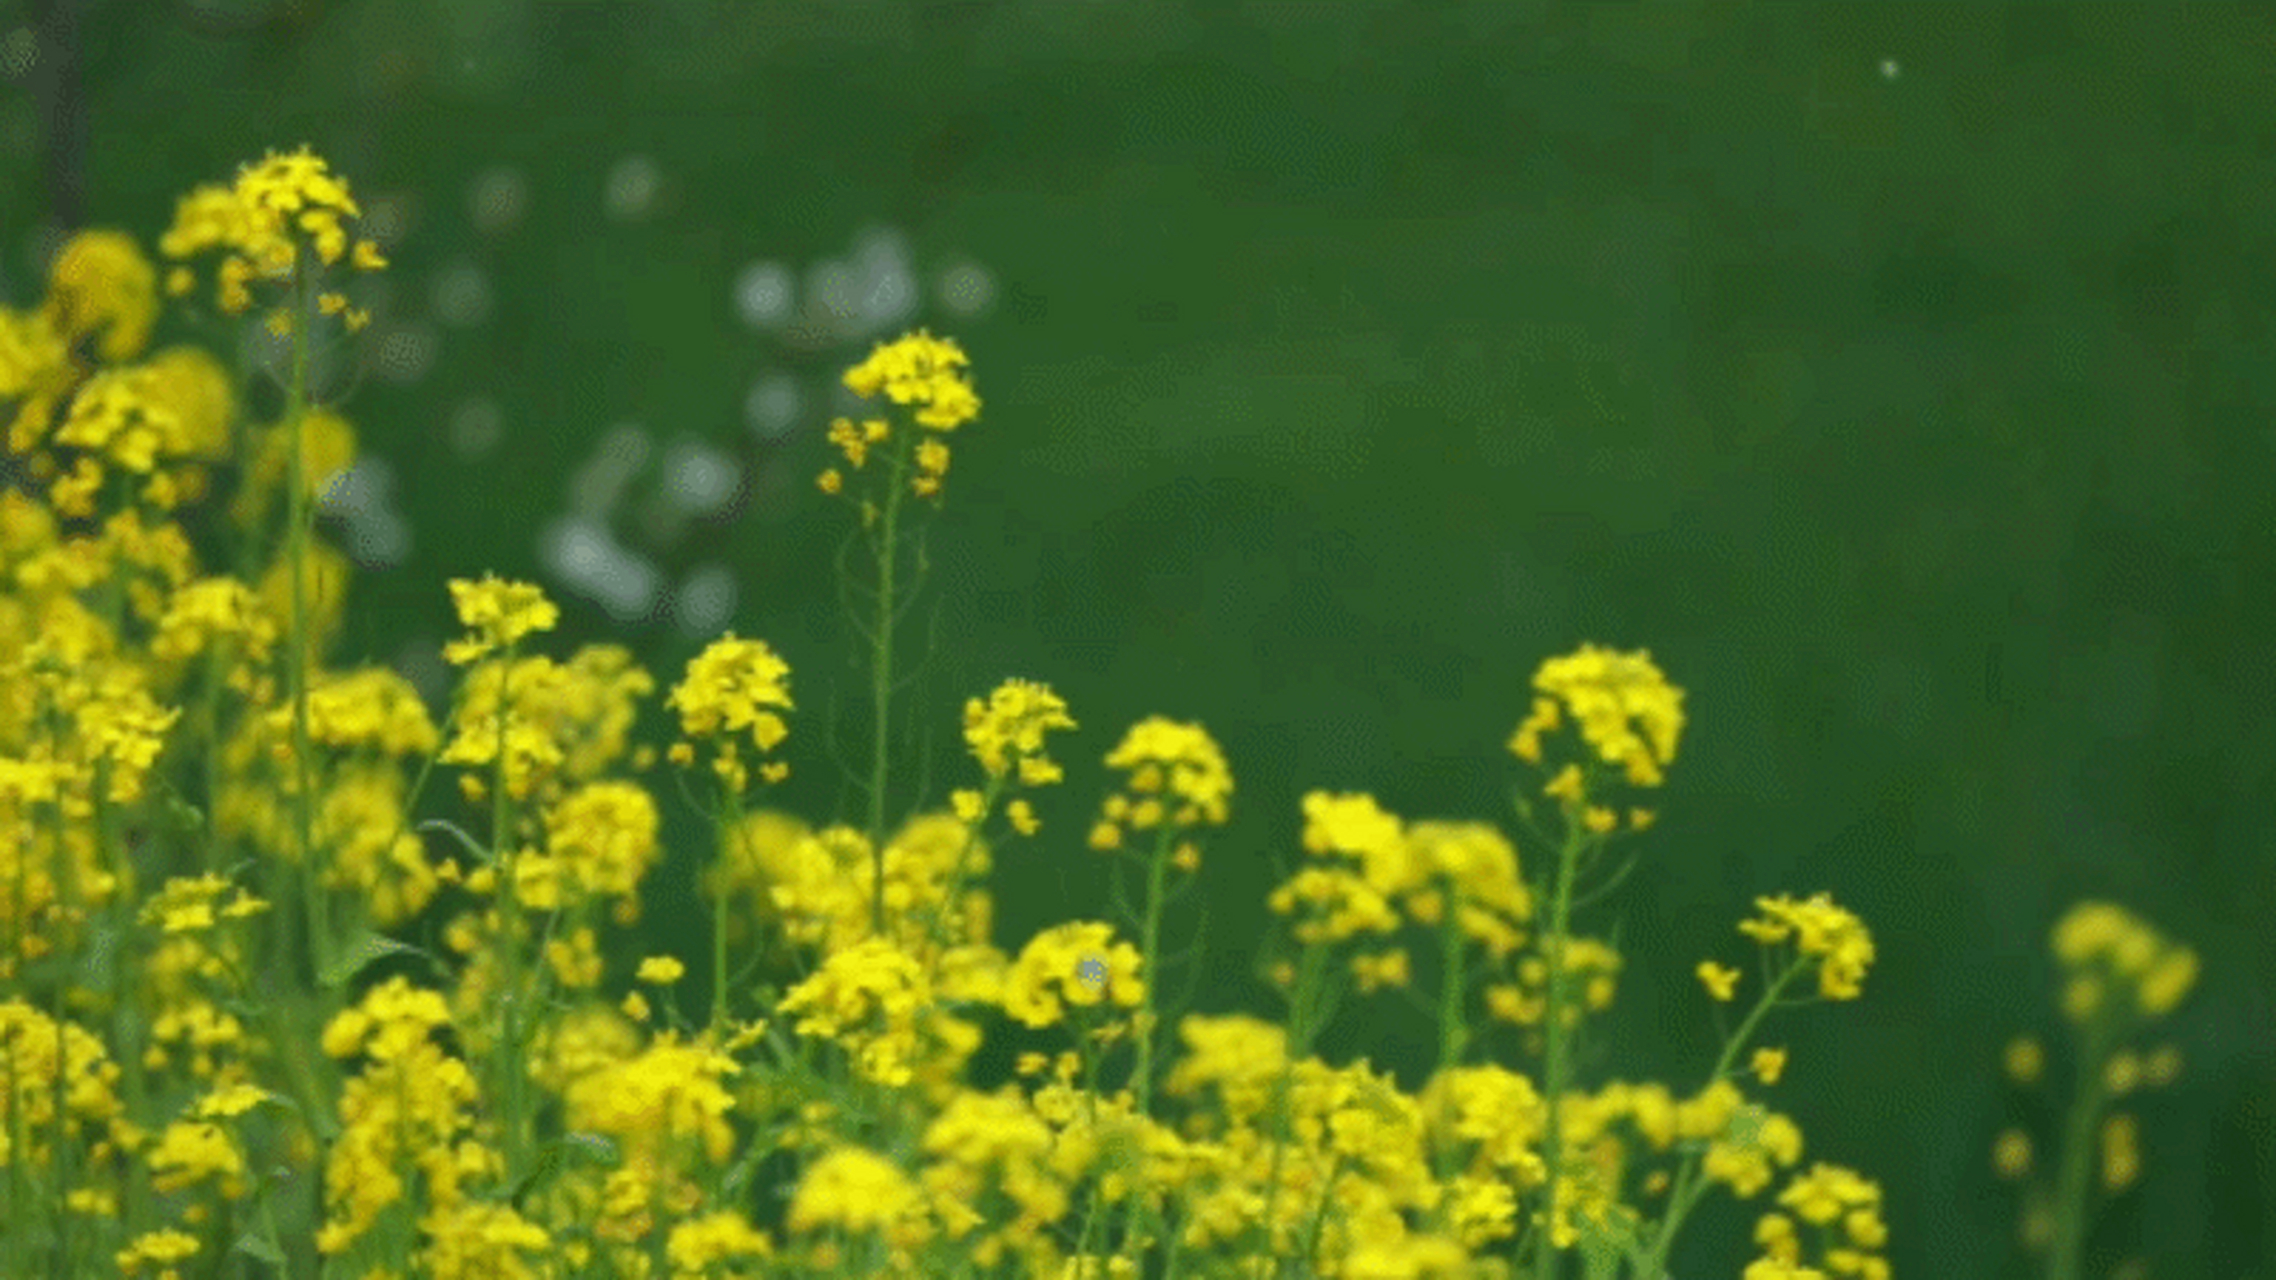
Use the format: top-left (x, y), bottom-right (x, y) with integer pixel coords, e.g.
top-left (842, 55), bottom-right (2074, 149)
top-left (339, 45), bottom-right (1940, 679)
top-left (0, 0), bottom-right (2276, 1280)
